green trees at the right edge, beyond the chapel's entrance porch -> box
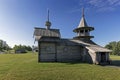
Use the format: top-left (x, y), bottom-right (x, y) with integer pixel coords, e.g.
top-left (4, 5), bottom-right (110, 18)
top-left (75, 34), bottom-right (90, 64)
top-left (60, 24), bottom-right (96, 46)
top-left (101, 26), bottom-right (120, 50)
top-left (105, 41), bottom-right (120, 55)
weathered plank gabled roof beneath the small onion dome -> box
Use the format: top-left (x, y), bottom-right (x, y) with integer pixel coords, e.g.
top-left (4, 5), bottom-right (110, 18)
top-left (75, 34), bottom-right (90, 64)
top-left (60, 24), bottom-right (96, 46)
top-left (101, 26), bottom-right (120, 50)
top-left (34, 27), bottom-right (60, 40)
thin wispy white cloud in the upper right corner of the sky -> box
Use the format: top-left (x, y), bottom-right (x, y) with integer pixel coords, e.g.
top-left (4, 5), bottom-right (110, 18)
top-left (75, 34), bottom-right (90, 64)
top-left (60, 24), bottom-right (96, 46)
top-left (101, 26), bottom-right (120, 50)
top-left (80, 0), bottom-right (120, 11)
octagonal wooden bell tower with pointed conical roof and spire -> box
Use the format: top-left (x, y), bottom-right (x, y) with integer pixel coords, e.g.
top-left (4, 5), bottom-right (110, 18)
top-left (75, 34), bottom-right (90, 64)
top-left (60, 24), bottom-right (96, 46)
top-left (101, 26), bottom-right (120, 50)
top-left (73, 8), bottom-right (94, 41)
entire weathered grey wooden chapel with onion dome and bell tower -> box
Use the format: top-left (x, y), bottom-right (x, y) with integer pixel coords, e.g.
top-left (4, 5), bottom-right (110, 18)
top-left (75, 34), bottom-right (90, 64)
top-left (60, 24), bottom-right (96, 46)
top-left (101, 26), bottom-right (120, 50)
top-left (34, 9), bottom-right (111, 64)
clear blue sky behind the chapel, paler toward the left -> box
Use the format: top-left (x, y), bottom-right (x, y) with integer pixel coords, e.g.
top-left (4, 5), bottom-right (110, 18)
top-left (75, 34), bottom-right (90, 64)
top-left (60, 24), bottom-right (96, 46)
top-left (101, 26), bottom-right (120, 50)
top-left (0, 0), bottom-right (120, 47)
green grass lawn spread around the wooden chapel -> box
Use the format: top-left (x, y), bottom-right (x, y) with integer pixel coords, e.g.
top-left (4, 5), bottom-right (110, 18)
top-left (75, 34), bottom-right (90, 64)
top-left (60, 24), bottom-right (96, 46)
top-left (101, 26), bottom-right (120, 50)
top-left (0, 53), bottom-right (120, 80)
